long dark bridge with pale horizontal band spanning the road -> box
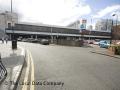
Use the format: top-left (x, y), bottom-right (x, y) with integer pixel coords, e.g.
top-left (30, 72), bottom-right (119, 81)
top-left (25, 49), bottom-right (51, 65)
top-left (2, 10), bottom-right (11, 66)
top-left (6, 23), bottom-right (111, 39)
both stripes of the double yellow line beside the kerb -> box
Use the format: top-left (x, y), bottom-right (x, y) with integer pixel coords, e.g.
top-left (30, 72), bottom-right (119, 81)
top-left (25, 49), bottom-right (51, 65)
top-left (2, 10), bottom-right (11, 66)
top-left (22, 50), bottom-right (35, 90)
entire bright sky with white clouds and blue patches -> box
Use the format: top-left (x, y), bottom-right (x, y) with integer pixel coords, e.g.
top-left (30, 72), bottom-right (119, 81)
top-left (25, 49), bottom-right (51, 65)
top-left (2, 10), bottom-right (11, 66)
top-left (0, 0), bottom-right (120, 26)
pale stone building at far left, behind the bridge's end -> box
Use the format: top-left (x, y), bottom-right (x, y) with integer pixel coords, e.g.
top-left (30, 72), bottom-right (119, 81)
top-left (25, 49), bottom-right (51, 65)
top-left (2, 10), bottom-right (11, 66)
top-left (0, 11), bottom-right (18, 38)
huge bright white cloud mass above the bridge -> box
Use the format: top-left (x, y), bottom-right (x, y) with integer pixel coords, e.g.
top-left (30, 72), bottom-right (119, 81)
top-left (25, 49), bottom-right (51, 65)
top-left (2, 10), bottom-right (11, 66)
top-left (0, 0), bottom-right (91, 26)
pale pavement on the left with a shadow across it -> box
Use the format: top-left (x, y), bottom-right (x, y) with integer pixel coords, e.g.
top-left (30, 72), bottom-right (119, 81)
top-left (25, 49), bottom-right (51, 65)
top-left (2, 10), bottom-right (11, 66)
top-left (0, 42), bottom-right (25, 90)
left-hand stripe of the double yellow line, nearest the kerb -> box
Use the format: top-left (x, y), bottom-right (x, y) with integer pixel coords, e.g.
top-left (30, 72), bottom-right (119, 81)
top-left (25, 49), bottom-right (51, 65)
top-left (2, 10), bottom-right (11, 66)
top-left (22, 51), bottom-right (30, 90)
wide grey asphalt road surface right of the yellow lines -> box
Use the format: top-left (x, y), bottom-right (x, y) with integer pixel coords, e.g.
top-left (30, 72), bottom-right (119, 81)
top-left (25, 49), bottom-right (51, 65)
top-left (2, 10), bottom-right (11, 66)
top-left (19, 43), bottom-right (120, 90)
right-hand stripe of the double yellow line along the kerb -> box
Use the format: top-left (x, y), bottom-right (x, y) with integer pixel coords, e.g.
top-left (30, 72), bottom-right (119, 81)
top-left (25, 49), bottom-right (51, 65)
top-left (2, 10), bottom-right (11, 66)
top-left (29, 52), bottom-right (35, 90)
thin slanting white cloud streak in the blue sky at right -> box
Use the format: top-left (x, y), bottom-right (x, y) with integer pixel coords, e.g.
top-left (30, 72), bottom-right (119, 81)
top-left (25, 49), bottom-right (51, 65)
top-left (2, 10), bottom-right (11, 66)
top-left (92, 5), bottom-right (120, 18)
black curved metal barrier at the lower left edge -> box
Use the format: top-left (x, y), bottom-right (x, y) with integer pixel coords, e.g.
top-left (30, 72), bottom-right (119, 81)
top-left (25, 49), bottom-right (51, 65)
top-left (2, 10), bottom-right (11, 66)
top-left (0, 53), bottom-right (7, 83)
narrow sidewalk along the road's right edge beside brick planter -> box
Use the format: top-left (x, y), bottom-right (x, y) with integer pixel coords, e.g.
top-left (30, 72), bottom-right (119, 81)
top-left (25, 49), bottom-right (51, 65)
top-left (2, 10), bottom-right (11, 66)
top-left (91, 45), bottom-right (120, 59)
